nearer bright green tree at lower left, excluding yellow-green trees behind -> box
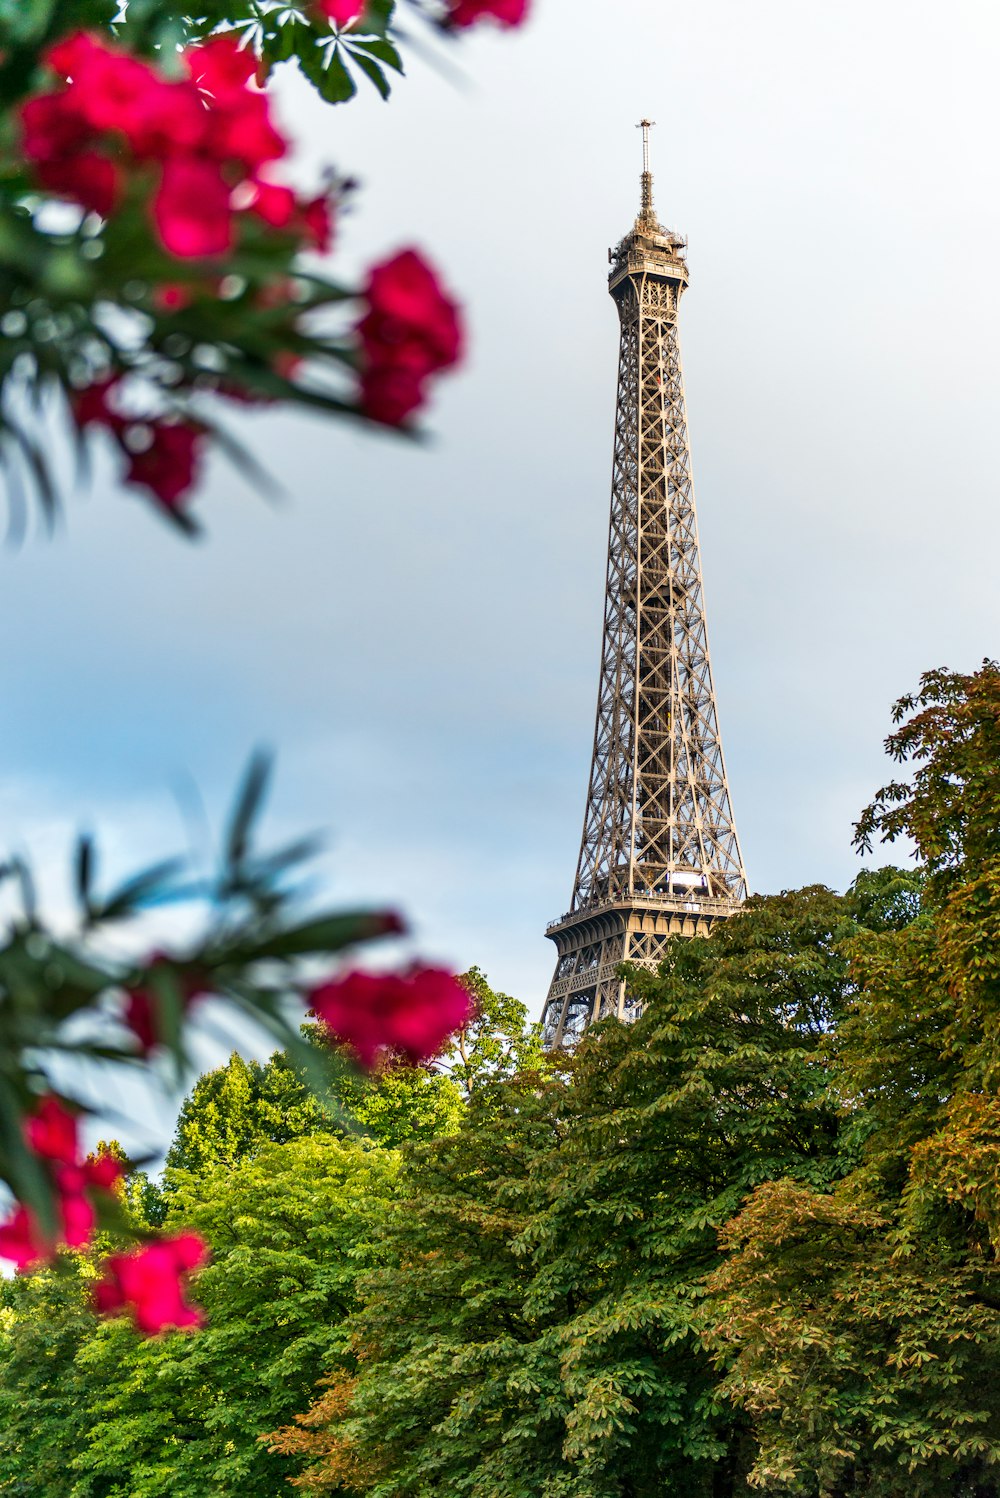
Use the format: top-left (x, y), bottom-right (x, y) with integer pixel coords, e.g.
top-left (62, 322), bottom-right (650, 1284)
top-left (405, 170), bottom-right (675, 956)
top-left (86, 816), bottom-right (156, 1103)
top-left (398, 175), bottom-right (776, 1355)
top-left (0, 1134), bottom-right (397, 1498)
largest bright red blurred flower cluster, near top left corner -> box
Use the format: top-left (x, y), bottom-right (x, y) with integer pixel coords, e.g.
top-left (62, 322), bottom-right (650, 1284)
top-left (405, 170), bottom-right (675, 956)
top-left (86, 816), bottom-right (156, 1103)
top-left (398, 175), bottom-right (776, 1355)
top-left (21, 31), bottom-right (331, 259)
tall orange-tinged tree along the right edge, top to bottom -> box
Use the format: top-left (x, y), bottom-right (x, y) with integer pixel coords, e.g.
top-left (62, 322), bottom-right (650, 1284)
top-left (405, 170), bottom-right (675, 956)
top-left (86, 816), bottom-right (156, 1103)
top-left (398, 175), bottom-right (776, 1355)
top-left (710, 662), bottom-right (1000, 1498)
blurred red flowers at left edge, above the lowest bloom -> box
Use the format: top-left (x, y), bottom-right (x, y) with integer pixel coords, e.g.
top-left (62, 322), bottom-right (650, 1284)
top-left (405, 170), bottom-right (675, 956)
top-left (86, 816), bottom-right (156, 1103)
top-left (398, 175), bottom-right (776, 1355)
top-left (0, 1094), bottom-right (123, 1270)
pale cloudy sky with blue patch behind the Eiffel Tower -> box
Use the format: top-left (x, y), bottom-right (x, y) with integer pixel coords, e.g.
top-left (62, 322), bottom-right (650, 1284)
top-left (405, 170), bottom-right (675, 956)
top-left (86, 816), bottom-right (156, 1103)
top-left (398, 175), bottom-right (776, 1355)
top-left (0, 0), bottom-right (1000, 1090)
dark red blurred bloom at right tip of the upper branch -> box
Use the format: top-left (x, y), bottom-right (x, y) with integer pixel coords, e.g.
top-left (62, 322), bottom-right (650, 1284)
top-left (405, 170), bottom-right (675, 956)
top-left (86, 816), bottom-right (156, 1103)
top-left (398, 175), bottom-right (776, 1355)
top-left (358, 250), bottom-right (463, 427)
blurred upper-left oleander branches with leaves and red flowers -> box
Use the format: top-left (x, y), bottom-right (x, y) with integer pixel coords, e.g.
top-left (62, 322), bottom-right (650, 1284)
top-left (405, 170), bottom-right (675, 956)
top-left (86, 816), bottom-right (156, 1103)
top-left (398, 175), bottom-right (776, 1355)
top-left (0, 0), bottom-right (524, 532)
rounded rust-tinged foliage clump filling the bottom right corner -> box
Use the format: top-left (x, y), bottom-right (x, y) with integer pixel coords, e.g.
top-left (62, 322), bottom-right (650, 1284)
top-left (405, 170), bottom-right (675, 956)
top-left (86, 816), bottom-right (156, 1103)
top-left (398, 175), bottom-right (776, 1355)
top-left (710, 1179), bottom-right (1000, 1498)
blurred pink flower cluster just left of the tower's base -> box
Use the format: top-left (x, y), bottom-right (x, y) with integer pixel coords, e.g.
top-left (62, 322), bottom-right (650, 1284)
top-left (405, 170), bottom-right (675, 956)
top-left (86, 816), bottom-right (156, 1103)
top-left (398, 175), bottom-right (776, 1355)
top-left (308, 968), bottom-right (475, 1070)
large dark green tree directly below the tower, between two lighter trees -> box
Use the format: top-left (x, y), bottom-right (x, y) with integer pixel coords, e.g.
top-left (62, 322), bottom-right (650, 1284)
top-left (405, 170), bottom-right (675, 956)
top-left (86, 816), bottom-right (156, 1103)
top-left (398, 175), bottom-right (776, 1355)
top-left (275, 887), bottom-right (883, 1498)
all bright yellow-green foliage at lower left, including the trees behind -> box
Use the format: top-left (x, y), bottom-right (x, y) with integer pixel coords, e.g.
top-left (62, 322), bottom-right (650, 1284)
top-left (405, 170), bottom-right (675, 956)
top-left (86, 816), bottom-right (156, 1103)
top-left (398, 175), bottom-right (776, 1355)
top-left (0, 975), bottom-right (516, 1498)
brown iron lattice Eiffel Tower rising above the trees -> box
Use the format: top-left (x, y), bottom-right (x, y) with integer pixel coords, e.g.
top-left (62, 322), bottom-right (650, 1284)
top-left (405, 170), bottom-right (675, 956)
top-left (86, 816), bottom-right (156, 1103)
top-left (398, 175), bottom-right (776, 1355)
top-left (543, 120), bottom-right (747, 1047)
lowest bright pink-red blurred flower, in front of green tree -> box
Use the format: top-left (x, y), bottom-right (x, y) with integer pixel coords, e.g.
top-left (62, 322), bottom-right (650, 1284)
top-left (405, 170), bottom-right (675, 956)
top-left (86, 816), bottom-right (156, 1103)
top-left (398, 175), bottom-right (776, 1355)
top-left (93, 1233), bottom-right (208, 1336)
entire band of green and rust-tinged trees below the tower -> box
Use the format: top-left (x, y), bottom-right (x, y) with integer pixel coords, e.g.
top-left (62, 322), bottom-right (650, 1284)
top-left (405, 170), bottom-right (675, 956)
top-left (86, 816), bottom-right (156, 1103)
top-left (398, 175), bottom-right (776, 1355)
top-left (0, 664), bottom-right (1000, 1498)
